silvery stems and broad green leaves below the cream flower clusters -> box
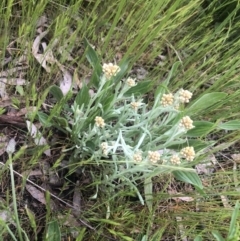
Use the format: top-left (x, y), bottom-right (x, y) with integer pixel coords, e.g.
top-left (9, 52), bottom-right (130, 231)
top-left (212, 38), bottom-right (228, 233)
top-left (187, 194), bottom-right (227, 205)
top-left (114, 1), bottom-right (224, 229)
top-left (39, 40), bottom-right (234, 208)
